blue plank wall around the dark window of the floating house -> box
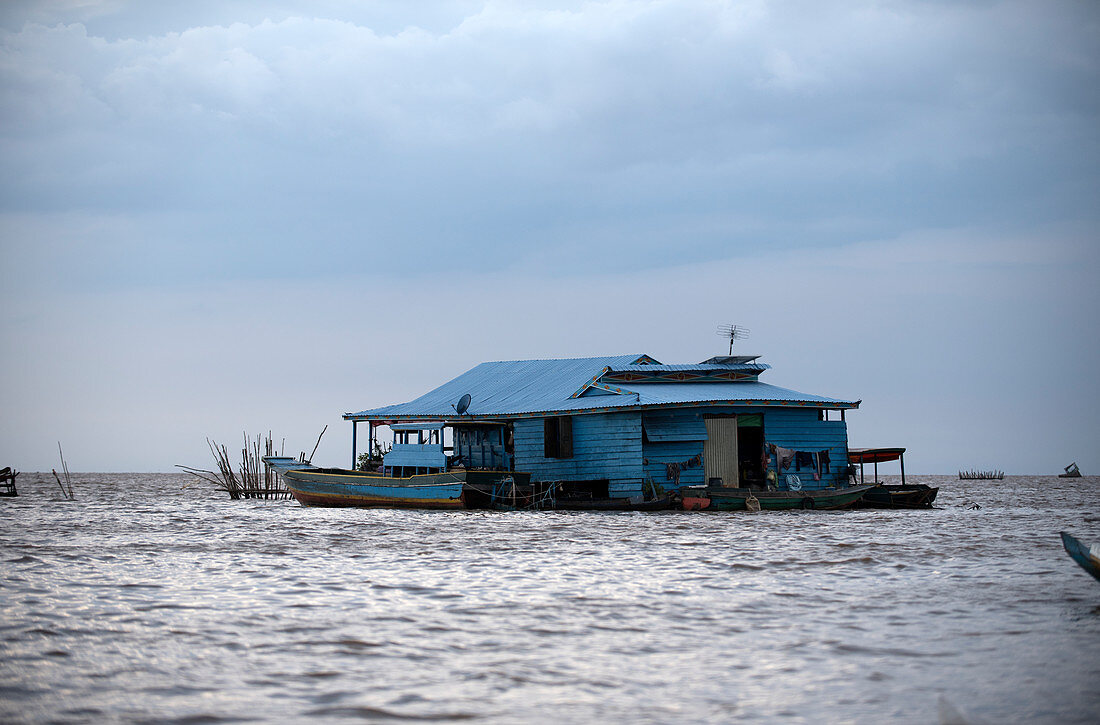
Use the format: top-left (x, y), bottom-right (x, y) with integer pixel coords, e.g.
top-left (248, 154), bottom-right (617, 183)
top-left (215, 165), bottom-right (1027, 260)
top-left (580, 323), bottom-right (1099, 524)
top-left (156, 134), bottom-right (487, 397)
top-left (513, 410), bottom-right (644, 498)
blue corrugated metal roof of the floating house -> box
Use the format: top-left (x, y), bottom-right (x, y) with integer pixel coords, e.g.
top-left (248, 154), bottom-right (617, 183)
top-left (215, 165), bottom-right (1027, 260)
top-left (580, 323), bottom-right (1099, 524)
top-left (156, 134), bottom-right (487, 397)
top-left (344, 355), bottom-right (857, 419)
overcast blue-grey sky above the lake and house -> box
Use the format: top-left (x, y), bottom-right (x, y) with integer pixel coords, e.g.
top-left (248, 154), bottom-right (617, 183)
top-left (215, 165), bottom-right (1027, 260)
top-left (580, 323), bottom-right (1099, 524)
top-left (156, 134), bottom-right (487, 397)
top-left (0, 0), bottom-right (1100, 474)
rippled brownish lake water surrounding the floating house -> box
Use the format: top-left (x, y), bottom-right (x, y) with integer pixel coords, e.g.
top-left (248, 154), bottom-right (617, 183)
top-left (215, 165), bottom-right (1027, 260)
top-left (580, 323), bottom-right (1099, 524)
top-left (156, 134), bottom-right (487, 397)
top-left (0, 473), bottom-right (1100, 723)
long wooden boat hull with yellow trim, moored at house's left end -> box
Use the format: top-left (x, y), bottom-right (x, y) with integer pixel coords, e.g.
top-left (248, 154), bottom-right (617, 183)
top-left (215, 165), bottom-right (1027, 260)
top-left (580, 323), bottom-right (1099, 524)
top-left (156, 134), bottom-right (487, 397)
top-left (264, 457), bottom-right (529, 508)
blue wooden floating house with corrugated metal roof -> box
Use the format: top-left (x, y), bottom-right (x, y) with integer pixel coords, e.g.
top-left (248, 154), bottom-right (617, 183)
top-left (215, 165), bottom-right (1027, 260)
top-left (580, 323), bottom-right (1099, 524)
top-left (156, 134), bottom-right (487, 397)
top-left (343, 354), bottom-right (860, 498)
